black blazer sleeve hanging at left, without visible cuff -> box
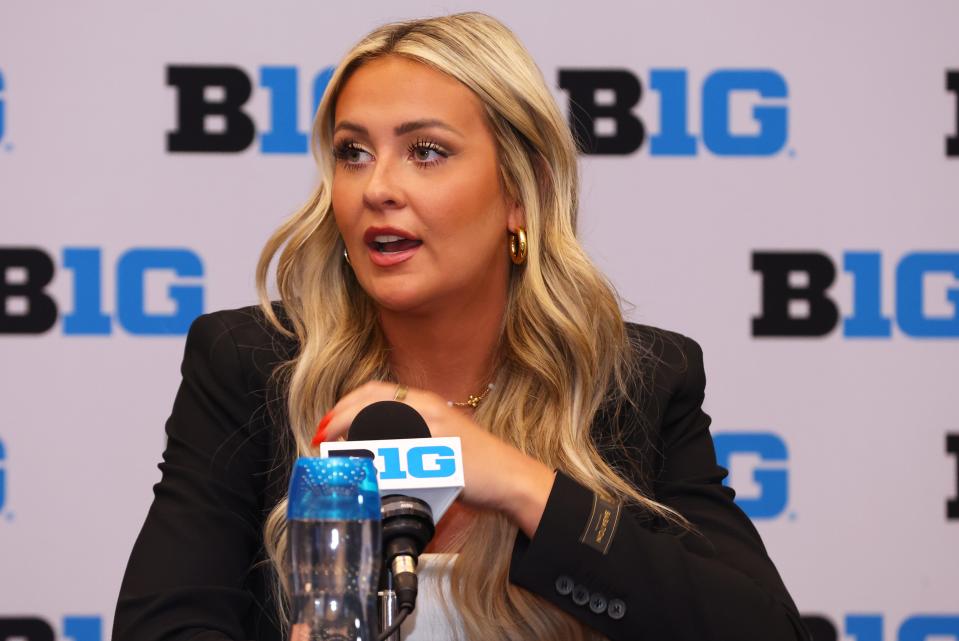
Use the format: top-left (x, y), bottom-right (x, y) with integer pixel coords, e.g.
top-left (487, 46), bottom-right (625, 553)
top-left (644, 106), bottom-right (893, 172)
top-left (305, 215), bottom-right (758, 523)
top-left (113, 314), bottom-right (276, 641)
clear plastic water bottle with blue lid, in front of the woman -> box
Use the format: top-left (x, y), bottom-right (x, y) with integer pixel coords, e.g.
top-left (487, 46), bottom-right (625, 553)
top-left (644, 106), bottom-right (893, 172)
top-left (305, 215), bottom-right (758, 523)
top-left (287, 457), bottom-right (381, 641)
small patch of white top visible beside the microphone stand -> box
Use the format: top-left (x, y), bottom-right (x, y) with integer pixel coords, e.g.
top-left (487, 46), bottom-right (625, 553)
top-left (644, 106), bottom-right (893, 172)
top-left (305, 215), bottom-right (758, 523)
top-left (400, 554), bottom-right (463, 641)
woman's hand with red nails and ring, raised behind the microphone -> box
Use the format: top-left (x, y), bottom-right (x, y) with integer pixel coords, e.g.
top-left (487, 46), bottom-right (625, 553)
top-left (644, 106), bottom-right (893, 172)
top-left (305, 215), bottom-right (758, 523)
top-left (320, 381), bottom-right (554, 537)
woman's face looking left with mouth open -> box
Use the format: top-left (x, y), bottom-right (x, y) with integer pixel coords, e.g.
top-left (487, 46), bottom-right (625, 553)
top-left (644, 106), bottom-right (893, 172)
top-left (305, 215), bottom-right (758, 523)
top-left (332, 56), bottom-right (523, 312)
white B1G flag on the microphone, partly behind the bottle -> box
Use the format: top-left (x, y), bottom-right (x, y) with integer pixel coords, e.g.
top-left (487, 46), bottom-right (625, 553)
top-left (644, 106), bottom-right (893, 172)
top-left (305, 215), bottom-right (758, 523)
top-left (320, 437), bottom-right (464, 521)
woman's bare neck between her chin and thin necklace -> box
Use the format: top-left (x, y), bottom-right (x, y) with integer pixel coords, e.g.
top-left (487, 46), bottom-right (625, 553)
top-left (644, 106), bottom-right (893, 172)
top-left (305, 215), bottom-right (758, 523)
top-left (380, 293), bottom-right (506, 402)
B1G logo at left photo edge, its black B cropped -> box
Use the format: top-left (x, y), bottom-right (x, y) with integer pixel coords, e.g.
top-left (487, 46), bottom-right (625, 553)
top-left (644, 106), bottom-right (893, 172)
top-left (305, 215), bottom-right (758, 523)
top-left (0, 247), bottom-right (203, 336)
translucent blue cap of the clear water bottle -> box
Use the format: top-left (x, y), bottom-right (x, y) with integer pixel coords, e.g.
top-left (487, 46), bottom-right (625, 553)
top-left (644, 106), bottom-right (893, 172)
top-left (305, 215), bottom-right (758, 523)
top-left (286, 456), bottom-right (380, 521)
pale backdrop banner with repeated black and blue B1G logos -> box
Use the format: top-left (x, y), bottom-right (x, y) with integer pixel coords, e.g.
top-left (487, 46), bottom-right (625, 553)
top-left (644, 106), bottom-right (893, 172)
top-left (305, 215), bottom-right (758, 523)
top-left (0, 0), bottom-right (959, 641)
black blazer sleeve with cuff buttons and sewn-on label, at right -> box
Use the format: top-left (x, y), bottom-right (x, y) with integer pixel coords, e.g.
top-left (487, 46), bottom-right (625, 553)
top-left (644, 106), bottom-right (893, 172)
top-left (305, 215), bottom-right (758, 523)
top-left (510, 338), bottom-right (809, 641)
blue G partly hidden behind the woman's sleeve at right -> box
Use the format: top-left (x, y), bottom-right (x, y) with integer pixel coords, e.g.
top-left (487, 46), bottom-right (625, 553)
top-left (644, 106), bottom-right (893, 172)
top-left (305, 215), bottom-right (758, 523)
top-left (713, 432), bottom-right (789, 519)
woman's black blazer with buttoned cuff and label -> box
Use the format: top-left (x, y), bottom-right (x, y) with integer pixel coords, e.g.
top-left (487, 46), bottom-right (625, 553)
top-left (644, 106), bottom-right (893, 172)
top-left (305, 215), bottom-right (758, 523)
top-left (113, 308), bottom-right (808, 641)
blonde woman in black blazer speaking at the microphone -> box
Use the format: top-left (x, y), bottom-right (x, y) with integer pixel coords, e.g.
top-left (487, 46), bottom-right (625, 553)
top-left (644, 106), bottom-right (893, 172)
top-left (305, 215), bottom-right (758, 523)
top-left (114, 13), bottom-right (804, 641)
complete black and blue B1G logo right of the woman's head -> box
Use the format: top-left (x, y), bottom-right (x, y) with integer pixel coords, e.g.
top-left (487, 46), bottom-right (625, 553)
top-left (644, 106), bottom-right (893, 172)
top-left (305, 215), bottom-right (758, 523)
top-left (559, 69), bottom-right (789, 157)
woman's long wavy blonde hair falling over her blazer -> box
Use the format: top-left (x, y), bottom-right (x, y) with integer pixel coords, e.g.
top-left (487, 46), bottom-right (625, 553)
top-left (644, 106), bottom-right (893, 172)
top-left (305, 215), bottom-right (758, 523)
top-left (257, 13), bottom-right (682, 641)
